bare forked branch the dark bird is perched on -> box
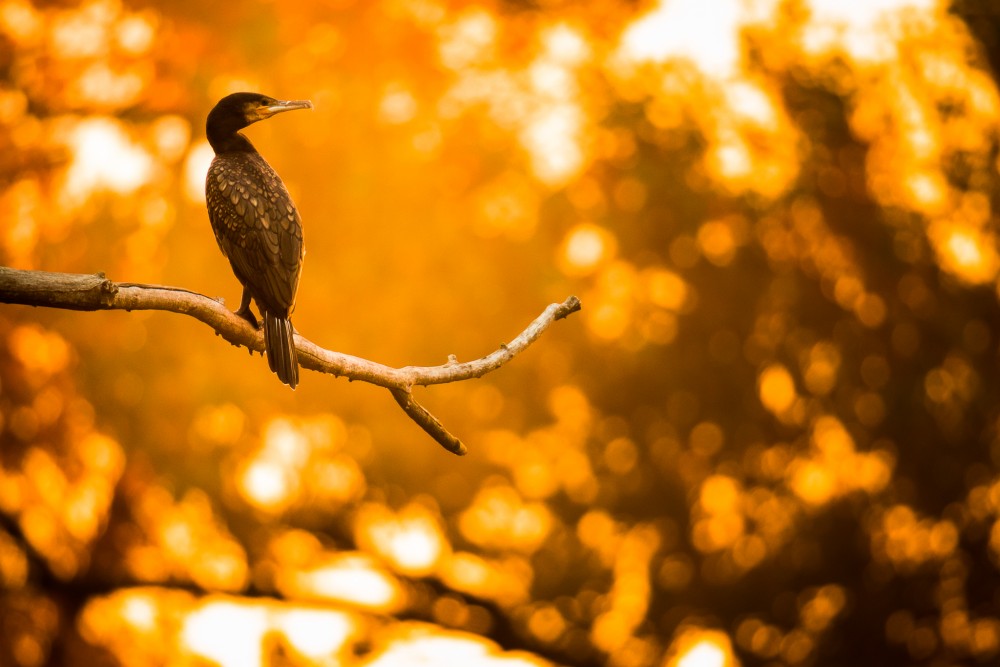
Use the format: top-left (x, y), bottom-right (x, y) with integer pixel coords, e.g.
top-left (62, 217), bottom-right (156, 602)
top-left (0, 266), bottom-right (580, 455)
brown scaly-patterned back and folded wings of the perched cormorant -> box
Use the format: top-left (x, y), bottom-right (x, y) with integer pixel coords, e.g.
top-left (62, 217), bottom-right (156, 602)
top-left (206, 153), bottom-right (303, 316)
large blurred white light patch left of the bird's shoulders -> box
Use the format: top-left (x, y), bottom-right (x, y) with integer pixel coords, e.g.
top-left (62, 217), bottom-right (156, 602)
top-left (65, 118), bottom-right (153, 202)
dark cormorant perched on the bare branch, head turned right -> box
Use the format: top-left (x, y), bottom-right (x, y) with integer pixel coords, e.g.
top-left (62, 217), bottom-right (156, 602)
top-left (205, 93), bottom-right (312, 389)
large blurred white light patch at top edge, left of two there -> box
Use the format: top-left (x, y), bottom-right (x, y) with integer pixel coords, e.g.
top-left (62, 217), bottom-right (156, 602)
top-left (620, 0), bottom-right (741, 78)
